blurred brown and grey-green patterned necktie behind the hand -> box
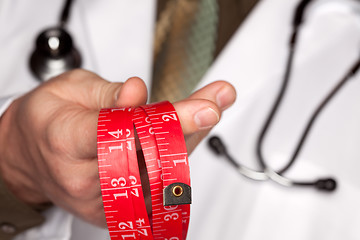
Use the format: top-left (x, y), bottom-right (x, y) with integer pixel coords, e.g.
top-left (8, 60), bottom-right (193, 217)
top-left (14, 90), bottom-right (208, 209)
top-left (151, 0), bottom-right (218, 102)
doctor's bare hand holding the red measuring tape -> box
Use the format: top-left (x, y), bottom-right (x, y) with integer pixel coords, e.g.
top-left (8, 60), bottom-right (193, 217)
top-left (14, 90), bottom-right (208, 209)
top-left (0, 70), bottom-right (235, 226)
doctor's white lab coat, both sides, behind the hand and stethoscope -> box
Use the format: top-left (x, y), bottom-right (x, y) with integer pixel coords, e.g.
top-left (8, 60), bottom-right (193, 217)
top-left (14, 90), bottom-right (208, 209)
top-left (0, 0), bottom-right (360, 240)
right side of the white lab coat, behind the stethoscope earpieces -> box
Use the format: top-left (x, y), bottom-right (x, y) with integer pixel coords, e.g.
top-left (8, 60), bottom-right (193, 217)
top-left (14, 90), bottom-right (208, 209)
top-left (189, 0), bottom-right (360, 240)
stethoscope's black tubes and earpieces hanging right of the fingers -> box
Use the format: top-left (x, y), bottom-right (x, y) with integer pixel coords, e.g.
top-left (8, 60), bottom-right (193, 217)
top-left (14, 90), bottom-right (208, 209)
top-left (208, 0), bottom-right (360, 192)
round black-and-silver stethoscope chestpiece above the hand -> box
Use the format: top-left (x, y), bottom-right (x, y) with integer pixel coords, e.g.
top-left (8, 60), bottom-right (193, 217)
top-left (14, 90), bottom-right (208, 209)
top-left (30, 27), bottom-right (81, 81)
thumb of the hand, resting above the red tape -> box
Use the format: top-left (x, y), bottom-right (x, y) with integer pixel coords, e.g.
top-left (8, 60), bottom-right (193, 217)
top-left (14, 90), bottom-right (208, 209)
top-left (44, 69), bottom-right (147, 110)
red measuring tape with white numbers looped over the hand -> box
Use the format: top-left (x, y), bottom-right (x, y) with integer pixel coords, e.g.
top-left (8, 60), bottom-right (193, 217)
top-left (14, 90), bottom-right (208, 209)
top-left (97, 102), bottom-right (191, 240)
